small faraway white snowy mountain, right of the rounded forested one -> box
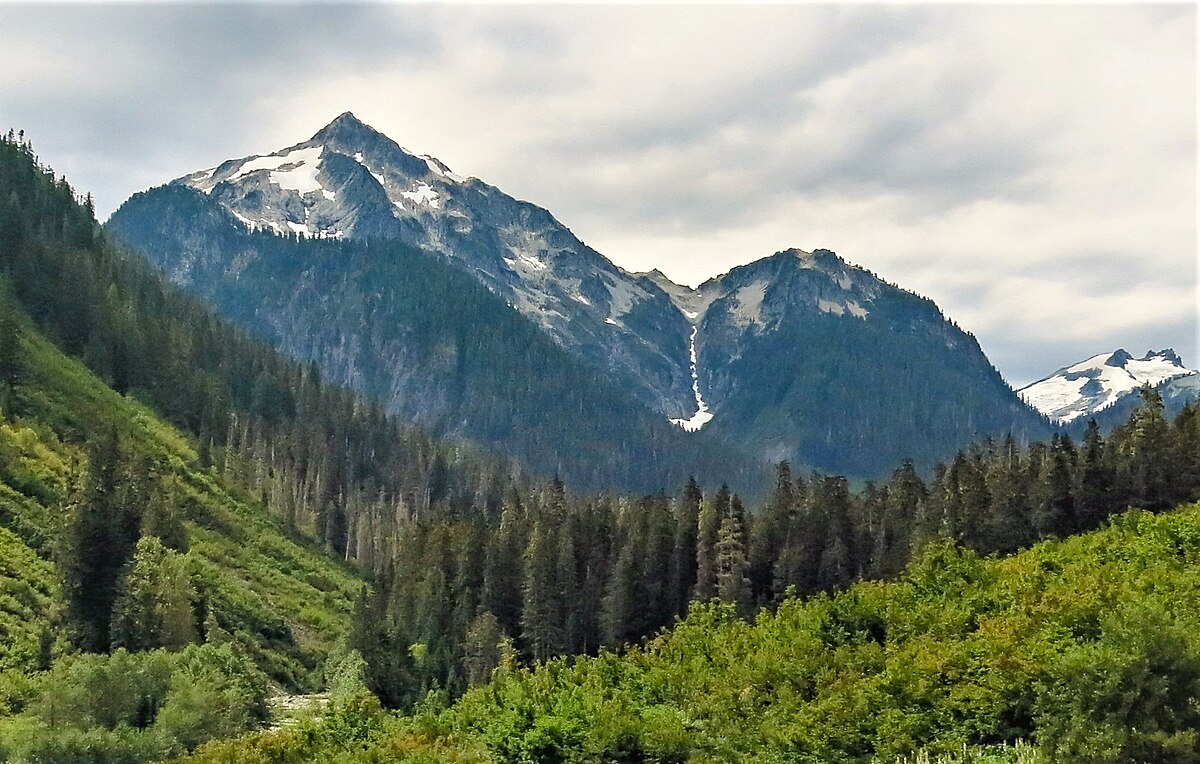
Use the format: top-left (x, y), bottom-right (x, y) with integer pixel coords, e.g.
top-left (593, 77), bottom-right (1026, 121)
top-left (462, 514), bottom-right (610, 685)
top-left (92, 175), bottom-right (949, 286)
top-left (1018, 348), bottom-right (1200, 425)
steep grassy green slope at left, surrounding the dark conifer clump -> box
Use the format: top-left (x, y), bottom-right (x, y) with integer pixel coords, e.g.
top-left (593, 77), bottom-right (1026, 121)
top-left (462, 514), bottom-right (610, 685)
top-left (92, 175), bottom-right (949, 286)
top-left (0, 299), bottom-right (361, 688)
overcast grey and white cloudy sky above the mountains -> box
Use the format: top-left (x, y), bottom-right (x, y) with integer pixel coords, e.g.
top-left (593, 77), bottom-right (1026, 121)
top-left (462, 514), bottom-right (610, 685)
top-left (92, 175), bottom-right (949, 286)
top-left (0, 4), bottom-right (1200, 385)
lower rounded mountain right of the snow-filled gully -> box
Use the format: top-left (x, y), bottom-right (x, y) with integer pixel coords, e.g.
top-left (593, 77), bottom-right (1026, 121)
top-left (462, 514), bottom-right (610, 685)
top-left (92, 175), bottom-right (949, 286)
top-left (644, 249), bottom-right (1049, 476)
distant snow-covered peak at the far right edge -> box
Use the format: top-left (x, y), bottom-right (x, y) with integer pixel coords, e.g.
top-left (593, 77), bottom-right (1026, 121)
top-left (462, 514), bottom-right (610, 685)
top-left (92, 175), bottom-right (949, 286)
top-left (1018, 348), bottom-right (1200, 425)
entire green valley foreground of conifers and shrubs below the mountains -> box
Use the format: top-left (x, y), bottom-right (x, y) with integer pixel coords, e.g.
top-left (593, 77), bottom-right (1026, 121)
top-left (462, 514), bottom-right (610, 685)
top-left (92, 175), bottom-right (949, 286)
top-left (0, 134), bottom-right (1200, 762)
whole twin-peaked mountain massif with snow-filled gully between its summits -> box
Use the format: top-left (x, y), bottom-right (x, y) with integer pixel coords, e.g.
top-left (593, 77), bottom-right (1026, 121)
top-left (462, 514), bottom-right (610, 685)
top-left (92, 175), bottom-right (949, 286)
top-left (107, 113), bottom-right (1049, 489)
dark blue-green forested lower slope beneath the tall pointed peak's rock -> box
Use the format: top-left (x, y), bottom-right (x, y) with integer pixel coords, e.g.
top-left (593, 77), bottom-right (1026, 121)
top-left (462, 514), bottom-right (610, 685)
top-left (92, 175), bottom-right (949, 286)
top-left (109, 185), bottom-right (755, 491)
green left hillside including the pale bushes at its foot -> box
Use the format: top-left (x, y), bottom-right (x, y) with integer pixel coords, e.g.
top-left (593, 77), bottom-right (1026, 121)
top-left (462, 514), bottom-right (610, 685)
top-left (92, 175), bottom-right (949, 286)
top-left (0, 275), bottom-right (362, 763)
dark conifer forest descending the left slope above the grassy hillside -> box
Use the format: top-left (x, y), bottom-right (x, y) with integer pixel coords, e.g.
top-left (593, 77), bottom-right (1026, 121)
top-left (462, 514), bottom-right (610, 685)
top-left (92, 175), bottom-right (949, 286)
top-left (0, 131), bottom-right (523, 567)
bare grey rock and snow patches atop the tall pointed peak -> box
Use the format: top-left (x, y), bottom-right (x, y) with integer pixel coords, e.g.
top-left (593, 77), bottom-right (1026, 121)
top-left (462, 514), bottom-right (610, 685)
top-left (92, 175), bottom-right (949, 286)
top-left (174, 112), bottom-right (694, 416)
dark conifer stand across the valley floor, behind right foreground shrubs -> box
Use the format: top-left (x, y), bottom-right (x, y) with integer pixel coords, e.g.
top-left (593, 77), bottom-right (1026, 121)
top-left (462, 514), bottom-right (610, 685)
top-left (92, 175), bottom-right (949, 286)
top-left (352, 390), bottom-right (1200, 706)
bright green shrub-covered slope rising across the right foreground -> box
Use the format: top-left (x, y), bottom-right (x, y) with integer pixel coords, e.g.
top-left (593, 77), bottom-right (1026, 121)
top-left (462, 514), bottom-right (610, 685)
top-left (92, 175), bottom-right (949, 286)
top-left (182, 505), bottom-right (1200, 764)
